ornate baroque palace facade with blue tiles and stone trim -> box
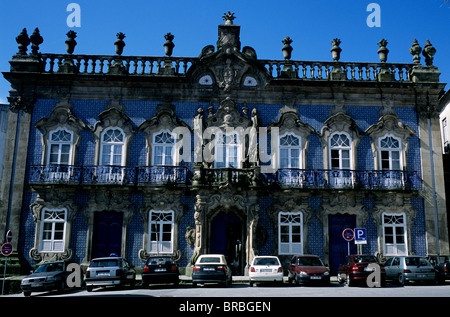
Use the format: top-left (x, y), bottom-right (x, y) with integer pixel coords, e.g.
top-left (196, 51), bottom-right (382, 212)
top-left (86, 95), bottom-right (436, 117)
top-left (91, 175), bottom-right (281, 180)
top-left (0, 13), bottom-right (449, 275)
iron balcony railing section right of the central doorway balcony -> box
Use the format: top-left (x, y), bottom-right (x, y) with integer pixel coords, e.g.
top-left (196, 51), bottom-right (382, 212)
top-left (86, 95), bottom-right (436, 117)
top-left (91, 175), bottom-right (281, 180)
top-left (274, 169), bottom-right (422, 190)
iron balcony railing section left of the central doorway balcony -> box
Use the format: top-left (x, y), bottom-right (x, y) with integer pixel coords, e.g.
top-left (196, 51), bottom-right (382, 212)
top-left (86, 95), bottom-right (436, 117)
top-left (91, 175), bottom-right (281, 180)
top-left (28, 165), bottom-right (188, 185)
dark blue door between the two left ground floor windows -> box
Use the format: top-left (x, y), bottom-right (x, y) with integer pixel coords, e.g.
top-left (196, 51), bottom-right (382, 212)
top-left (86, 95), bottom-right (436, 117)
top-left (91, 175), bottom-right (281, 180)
top-left (92, 212), bottom-right (123, 258)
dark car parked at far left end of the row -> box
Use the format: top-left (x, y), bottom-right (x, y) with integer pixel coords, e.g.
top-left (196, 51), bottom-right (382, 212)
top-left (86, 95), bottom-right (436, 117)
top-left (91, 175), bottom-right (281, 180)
top-left (20, 260), bottom-right (83, 296)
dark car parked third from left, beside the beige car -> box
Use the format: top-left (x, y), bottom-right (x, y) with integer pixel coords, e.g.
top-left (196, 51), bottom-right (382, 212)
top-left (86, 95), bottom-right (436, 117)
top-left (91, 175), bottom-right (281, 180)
top-left (142, 256), bottom-right (180, 287)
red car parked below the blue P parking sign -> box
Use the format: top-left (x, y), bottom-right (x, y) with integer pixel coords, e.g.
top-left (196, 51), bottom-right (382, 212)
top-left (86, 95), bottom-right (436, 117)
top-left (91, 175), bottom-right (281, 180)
top-left (337, 255), bottom-right (386, 286)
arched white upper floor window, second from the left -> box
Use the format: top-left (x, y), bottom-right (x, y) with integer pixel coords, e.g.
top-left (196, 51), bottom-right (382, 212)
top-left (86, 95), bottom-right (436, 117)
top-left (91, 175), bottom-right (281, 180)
top-left (100, 128), bottom-right (125, 165)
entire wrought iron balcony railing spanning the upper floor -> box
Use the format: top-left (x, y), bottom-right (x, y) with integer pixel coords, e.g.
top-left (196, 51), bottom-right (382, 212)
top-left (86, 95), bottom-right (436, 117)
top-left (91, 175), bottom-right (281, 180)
top-left (28, 165), bottom-right (422, 190)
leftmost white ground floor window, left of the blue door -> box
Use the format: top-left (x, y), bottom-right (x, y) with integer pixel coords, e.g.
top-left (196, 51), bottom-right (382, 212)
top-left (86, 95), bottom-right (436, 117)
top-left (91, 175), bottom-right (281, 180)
top-left (39, 209), bottom-right (67, 252)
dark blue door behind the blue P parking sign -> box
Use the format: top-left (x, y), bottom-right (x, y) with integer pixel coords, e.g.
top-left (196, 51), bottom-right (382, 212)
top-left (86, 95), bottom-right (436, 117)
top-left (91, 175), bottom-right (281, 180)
top-left (328, 214), bottom-right (356, 275)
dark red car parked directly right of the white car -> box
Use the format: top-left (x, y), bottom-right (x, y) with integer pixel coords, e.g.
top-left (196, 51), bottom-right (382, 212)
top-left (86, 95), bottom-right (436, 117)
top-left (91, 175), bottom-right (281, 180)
top-left (288, 255), bottom-right (330, 285)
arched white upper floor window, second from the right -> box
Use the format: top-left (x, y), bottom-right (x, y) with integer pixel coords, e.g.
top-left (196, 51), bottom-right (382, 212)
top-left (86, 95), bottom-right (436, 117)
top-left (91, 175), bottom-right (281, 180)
top-left (329, 132), bottom-right (351, 169)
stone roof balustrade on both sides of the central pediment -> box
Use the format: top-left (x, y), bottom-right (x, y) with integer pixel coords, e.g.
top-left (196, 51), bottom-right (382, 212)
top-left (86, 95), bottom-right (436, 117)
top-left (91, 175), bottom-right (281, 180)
top-left (36, 54), bottom-right (414, 82)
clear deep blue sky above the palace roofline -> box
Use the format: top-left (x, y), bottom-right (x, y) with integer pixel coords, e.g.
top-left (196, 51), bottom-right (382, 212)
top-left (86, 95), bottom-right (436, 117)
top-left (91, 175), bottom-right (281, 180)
top-left (0, 0), bottom-right (450, 103)
